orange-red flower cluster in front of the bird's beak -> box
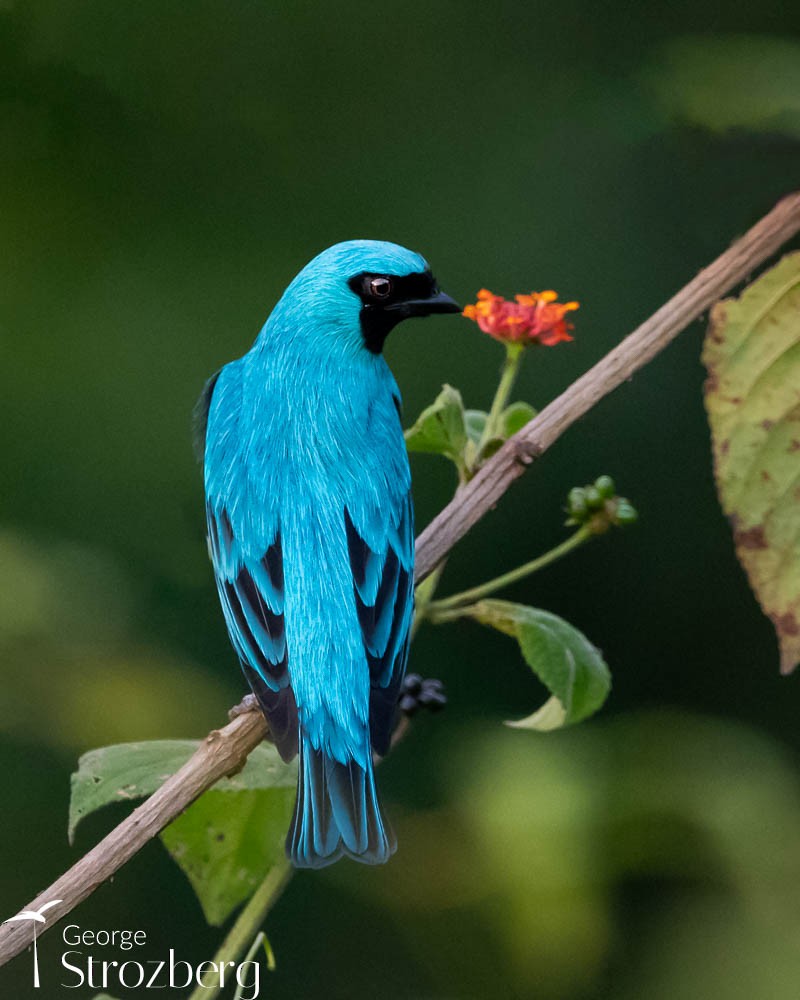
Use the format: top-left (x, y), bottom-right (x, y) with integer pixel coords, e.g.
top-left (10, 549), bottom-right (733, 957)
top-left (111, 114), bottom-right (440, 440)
top-left (462, 288), bottom-right (578, 347)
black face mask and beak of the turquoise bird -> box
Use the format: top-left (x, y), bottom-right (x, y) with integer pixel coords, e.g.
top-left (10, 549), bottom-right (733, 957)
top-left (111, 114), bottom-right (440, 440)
top-left (347, 271), bottom-right (461, 354)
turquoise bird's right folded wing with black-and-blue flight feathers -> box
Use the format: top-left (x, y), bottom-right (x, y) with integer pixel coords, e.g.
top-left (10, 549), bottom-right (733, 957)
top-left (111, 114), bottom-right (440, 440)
top-left (345, 493), bottom-right (414, 756)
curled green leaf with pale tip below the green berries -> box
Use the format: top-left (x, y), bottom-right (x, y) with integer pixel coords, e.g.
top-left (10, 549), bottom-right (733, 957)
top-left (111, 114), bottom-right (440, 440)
top-left (465, 601), bottom-right (611, 732)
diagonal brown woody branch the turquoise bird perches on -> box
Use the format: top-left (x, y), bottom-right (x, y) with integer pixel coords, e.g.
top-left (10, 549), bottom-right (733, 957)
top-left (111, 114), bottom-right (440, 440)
top-left (0, 192), bottom-right (800, 965)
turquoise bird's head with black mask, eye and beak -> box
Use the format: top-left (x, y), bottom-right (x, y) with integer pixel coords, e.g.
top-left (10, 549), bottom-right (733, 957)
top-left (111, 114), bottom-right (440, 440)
top-left (270, 240), bottom-right (461, 354)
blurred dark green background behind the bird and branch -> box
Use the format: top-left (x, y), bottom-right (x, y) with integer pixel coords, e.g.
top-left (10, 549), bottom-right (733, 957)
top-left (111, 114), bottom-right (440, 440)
top-left (0, 0), bottom-right (800, 1000)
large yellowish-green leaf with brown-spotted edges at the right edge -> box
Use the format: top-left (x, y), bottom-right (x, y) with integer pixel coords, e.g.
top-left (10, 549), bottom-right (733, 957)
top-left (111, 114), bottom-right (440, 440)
top-left (703, 253), bottom-right (800, 673)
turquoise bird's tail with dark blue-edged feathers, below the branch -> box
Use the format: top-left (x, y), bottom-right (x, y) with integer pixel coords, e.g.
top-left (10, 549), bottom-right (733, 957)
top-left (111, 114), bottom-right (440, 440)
top-left (286, 733), bottom-right (397, 868)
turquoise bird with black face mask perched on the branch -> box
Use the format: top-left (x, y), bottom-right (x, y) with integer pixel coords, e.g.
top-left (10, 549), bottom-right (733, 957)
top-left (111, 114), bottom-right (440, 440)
top-left (195, 240), bottom-right (461, 868)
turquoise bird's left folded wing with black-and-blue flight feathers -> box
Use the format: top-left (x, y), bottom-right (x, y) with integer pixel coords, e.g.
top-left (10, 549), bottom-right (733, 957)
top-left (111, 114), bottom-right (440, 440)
top-left (206, 503), bottom-right (298, 761)
